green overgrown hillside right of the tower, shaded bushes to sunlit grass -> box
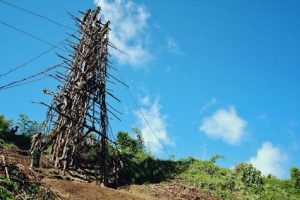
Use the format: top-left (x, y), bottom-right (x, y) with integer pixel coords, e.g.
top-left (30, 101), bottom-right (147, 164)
top-left (104, 132), bottom-right (300, 200)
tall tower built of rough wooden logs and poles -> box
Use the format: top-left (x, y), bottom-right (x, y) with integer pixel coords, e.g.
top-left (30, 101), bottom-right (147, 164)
top-left (44, 8), bottom-right (115, 185)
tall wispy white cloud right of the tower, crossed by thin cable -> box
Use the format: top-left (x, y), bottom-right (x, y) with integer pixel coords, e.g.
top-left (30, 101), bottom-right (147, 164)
top-left (134, 97), bottom-right (174, 154)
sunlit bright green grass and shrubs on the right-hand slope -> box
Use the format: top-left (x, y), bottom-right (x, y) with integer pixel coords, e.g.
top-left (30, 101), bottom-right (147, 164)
top-left (179, 160), bottom-right (300, 200)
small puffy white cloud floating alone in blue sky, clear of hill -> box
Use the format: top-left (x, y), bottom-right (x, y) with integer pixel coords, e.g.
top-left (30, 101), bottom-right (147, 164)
top-left (199, 107), bottom-right (247, 144)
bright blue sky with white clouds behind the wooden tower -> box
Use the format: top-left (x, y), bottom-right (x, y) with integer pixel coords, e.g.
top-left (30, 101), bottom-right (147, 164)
top-left (0, 0), bottom-right (300, 178)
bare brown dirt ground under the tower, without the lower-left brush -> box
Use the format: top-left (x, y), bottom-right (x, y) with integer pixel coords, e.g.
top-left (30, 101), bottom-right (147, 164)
top-left (0, 149), bottom-right (217, 200)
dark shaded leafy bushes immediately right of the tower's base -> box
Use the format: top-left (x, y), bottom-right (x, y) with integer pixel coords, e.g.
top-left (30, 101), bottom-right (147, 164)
top-left (115, 129), bottom-right (182, 185)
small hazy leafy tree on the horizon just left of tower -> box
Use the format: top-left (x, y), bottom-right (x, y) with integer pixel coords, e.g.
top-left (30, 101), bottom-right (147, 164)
top-left (17, 114), bottom-right (42, 136)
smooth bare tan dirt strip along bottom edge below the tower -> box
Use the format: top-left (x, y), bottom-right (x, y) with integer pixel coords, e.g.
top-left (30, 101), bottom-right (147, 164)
top-left (42, 178), bottom-right (215, 200)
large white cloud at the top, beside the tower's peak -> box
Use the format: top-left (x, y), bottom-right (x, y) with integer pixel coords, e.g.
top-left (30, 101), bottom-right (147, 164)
top-left (94, 0), bottom-right (151, 68)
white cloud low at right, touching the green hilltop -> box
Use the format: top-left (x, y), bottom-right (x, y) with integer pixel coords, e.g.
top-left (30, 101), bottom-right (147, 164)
top-left (249, 142), bottom-right (287, 178)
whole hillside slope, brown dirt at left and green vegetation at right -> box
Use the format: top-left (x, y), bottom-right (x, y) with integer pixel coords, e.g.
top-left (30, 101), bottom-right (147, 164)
top-left (0, 141), bottom-right (300, 200)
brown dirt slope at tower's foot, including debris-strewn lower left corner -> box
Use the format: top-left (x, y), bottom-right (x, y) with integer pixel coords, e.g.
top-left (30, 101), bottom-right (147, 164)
top-left (0, 148), bottom-right (217, 200)
